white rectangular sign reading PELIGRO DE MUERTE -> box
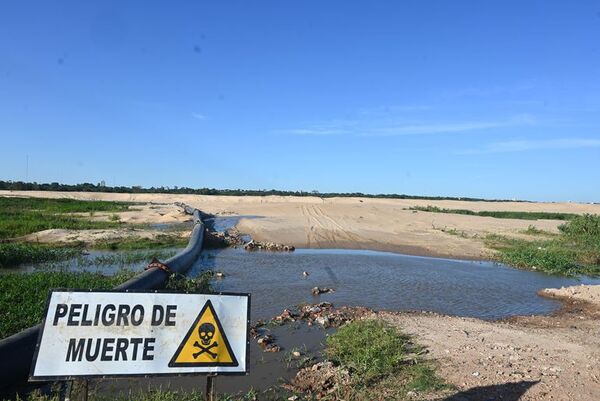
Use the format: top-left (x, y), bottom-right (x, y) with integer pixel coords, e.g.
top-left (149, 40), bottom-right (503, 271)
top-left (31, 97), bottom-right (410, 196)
top-left (30, 291), bottom-right (250, 380)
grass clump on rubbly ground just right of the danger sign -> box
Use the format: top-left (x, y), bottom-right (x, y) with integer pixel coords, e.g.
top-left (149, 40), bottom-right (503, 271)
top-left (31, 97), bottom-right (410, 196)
top-left (326, 320), bottom-right (447, 400)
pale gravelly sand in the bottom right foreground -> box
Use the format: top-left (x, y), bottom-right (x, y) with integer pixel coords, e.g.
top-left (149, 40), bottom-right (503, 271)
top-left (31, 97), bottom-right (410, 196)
top-left (379, 289), bottom-right (600, 401)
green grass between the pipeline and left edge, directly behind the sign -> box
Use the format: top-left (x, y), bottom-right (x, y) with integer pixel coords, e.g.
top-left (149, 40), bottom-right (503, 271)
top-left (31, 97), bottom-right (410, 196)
top-left (0, 271), bottom-right (134, 338)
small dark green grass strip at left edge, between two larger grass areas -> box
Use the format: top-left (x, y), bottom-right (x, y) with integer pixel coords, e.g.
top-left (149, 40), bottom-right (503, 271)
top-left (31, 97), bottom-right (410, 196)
top-left (0, 243), bottom-right (81, 269)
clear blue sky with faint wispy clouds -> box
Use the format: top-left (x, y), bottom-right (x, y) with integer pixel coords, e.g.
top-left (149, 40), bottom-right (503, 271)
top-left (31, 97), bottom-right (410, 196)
top-left (0, 0), bottom-right (600, 201)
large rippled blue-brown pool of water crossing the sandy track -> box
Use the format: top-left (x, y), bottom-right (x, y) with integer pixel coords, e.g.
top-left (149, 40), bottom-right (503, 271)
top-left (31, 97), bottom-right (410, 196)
top-left (189, 249), bottom-right (600, 319)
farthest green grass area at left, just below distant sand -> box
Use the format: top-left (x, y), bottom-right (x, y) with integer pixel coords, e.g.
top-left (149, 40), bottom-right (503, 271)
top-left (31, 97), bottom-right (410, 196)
top-left (0, 197), bottom-right (132, 240)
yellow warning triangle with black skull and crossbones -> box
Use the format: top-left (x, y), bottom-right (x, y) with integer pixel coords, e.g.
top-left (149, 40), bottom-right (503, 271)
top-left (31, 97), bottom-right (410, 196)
top-left (169, 301), bottom-right (238, 368)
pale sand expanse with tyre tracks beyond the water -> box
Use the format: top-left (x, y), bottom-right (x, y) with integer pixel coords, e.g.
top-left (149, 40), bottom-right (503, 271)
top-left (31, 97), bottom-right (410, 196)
top-left (0, 191), bottom-right (600, 259)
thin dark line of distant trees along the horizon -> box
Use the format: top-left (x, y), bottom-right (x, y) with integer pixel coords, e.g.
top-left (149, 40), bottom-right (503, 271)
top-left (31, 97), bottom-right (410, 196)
top-left (0, 181), bottom-right (523, 202)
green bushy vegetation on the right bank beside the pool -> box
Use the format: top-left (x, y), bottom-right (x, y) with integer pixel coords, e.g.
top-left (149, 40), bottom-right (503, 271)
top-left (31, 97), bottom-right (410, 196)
top-left (486, 214), bottom-right (600, 276)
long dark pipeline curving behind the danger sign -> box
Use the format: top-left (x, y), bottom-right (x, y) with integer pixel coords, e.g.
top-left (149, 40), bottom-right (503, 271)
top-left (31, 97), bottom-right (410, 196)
top-left (0, 203), bottom-right (204, 390)
